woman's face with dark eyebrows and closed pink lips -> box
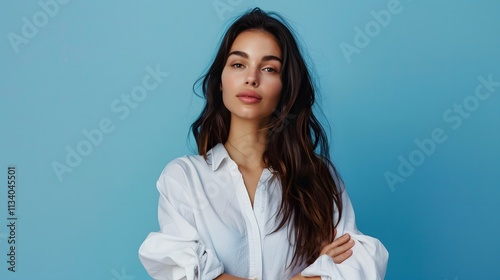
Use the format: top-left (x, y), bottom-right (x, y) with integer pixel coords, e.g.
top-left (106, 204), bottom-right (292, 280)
top-left (221, 30), bottom-right (283, 124)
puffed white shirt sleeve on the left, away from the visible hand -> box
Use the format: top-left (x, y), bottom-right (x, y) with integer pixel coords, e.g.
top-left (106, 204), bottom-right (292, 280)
top-left (139, 161), bottom-right (224, 280)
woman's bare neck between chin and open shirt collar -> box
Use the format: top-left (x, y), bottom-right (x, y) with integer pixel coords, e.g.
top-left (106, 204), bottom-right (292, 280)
top-left (224, 118), bottom-right (267, 169)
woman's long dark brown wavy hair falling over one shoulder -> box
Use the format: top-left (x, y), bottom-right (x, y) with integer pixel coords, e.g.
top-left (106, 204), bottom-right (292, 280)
top-left (191, 8), bottom-right (342, 264)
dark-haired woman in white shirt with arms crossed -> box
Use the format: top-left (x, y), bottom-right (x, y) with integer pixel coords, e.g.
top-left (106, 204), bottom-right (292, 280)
top-left (139, 8), bottom-right (388, 280)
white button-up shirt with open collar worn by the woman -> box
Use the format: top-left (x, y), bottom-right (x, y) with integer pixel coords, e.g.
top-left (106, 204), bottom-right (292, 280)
top-left (139, 144), bottom-right (388, 280)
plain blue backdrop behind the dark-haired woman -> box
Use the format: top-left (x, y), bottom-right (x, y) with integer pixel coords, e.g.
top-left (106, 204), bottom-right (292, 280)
top-left (0, 0), bottom-right (500, 280)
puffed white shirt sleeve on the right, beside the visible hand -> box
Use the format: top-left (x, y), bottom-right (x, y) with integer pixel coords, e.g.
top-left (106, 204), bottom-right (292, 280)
top-left (302, 184), bottom-right (389, 280)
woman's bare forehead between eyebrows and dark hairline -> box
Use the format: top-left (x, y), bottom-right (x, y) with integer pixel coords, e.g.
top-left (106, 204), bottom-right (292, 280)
top-left (230, 30), bottom-right (281, 56)
